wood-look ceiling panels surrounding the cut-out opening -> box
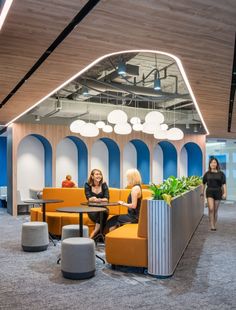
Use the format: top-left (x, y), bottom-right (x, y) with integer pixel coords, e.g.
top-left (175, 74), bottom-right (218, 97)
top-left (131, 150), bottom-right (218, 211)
top-left (0, 0), bottom-right (236, 138)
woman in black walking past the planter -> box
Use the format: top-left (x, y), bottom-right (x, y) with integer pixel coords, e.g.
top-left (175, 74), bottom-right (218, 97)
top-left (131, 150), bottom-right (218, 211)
top-left (201, 157), bottom-right (226, 231)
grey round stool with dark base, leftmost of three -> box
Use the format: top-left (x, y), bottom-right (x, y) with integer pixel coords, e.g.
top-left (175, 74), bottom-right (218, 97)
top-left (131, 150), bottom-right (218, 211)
top-left (21, 222), bottom-right (49, 252)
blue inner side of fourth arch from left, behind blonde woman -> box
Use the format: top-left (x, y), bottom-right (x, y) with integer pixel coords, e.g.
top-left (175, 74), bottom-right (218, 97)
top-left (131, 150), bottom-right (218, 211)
top-left (130, 139), bottom-right (150, 184)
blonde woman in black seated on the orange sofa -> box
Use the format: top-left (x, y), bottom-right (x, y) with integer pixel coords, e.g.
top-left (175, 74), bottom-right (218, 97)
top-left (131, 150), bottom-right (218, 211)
top-left (107, 169), bottom-right (142, 231)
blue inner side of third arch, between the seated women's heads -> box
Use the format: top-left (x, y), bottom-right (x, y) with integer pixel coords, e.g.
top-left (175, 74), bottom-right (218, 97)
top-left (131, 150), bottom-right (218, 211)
top-left (100, 138), bottom-right (120, 188)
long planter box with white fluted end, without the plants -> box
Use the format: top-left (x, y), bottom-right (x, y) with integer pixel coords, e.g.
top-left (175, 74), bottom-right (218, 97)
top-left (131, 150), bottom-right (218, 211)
top-left (148, 186), bottom-right (204, 277)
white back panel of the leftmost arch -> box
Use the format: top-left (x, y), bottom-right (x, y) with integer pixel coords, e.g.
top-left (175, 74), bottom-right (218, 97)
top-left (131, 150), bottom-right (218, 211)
top-left (17, 136), bottom-right (44, 200)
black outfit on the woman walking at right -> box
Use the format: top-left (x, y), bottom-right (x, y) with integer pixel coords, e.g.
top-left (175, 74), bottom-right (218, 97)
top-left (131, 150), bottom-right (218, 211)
top-left (202, 171), bottom-right (226, 200)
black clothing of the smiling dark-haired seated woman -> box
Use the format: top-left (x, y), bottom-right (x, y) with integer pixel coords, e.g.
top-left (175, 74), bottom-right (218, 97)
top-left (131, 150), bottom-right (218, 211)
top-left (84, 182), bottom-right (109, 230)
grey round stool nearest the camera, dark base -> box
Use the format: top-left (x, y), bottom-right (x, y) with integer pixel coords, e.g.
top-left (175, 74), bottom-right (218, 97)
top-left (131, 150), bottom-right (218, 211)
top-left (61, 238), bottom-right (95, 280)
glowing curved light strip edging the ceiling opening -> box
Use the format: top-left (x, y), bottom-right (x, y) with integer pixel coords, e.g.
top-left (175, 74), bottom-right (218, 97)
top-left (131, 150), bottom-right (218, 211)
top-left (3, 50), bottom-right (209, 135)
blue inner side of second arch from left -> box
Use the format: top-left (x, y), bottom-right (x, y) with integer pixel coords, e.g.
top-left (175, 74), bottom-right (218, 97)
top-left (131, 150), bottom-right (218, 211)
top-left (67, 136), bottom-right (88, 187)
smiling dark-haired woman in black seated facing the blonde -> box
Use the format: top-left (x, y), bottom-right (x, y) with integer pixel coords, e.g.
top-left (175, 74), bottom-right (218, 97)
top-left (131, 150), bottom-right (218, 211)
top-left (84, 169), bottom-right (109, 238)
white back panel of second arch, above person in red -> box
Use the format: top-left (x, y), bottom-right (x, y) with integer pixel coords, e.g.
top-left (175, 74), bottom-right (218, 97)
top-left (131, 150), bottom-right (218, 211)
top-left (56, 138), bottom-right (78, 187)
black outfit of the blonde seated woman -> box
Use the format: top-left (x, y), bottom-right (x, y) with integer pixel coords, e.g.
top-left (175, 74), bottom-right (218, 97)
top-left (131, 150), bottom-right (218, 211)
top-left (106, 184), bottom-right (143, 228)
